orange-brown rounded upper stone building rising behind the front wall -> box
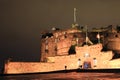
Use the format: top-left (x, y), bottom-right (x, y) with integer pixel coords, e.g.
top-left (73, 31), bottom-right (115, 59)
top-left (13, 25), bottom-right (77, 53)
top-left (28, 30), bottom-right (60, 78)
top-left (40, 28), bottom-right (85, 62)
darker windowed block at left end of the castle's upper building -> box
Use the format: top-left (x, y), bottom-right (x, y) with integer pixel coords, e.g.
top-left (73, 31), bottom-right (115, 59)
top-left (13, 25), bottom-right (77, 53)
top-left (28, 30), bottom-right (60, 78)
top-left (40, 33), bottom-right (56, 62)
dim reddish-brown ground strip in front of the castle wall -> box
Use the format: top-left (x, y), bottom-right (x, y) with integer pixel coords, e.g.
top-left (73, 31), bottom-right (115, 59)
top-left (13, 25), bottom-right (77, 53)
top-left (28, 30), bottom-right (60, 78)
top-left (0, 72), bottom-right (120, 80)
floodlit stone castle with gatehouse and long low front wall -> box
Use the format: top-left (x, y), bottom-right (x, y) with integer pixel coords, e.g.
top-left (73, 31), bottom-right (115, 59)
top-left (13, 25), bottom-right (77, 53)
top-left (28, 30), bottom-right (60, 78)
top-left (4, 24), bottom-right (120, 74)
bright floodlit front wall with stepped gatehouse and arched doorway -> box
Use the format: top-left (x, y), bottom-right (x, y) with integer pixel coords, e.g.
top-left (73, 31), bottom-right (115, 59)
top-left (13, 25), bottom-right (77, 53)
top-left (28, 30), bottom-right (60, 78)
top-left (5, 44), bottom-right (120, 74)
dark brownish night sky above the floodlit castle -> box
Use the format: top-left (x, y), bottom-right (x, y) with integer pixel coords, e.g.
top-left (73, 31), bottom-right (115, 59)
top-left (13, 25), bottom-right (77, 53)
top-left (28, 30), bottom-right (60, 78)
top-left (0, 0), bottom-right (120, 66)
